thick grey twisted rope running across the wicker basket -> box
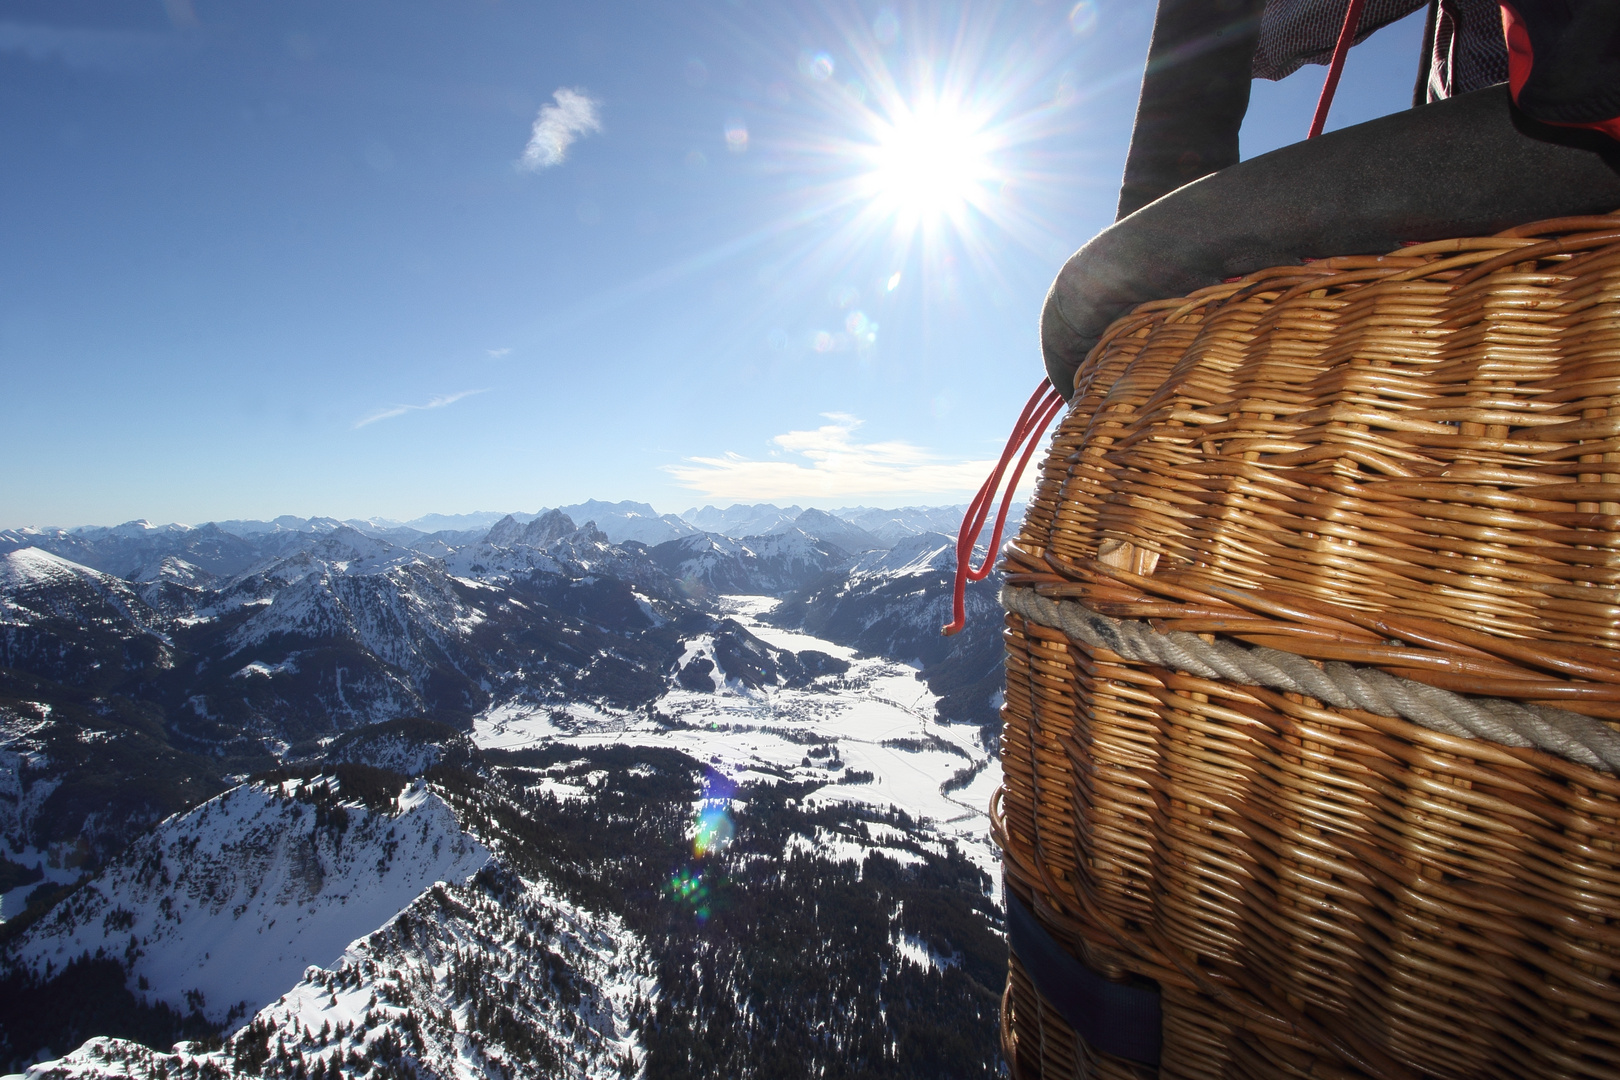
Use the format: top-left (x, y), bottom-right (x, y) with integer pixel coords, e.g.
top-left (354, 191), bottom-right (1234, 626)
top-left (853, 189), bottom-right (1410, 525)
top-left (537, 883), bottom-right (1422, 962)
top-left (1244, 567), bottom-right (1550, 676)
top-left (1001, 586), bottom-right (1620, 772)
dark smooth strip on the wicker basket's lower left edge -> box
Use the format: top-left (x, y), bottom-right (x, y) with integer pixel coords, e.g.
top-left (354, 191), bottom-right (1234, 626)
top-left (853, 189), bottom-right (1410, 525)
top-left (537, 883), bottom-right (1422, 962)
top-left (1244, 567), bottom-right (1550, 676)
top-left (1006, 891), bottom-right (1163, 1065)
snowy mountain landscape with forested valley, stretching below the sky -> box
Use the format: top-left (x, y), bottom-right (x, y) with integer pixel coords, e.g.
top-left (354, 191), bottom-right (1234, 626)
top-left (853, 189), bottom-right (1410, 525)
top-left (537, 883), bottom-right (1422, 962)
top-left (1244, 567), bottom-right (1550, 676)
top-left (0, 502), bottom-right (1001, 1078)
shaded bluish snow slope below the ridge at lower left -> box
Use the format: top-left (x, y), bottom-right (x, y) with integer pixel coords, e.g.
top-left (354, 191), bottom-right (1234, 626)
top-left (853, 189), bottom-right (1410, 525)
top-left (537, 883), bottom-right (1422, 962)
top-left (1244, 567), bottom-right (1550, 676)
top-left (11, 780), bottom-right (489, 1020)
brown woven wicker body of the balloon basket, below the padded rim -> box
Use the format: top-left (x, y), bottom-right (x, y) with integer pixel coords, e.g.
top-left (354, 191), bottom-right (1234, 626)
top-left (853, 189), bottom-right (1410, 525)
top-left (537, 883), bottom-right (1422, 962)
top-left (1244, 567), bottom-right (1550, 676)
top-left (993, 215), bottom-right (1620, 1078)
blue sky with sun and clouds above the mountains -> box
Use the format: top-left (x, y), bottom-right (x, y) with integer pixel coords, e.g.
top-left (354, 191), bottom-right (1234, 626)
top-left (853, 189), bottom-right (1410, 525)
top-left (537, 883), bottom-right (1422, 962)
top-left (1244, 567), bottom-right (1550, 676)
top-left (0, 0), bottom-right (1421, 526)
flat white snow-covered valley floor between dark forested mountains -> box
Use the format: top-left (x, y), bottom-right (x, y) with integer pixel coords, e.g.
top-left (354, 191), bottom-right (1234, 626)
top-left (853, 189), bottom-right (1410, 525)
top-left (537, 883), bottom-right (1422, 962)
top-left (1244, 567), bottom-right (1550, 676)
top-left (473, 596), bottom-right (1001, 878)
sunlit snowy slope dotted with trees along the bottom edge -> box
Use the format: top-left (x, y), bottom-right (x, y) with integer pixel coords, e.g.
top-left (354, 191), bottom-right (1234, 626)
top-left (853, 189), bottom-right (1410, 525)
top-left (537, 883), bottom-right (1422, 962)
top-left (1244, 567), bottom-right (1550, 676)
top-left (15, 873), bottom-right (656, 1080)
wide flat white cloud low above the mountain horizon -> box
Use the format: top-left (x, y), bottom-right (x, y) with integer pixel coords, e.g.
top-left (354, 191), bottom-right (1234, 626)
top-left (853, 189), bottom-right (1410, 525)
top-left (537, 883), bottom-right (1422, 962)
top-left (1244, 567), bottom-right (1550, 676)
top-left (664, 413), bottom-right (995, 502)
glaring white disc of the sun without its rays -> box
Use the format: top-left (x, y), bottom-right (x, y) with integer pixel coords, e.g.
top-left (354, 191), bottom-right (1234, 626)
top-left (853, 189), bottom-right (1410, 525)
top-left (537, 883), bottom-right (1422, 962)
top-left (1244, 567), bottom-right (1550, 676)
top-left (865, 102), bottom-right (995, 223)
